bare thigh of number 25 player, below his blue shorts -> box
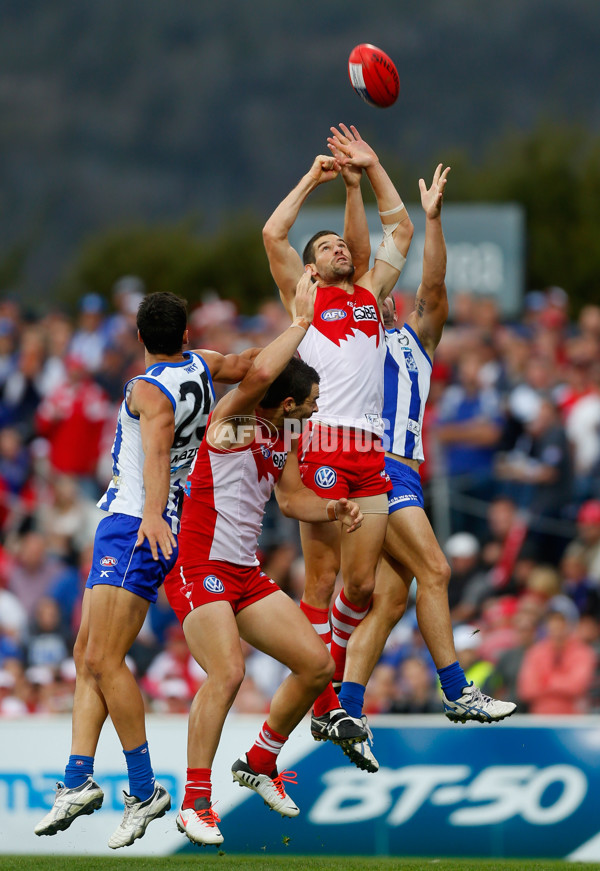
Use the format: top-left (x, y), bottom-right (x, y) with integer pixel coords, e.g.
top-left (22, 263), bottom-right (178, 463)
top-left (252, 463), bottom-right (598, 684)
top-left (87, 584), bottom-right (150, 660)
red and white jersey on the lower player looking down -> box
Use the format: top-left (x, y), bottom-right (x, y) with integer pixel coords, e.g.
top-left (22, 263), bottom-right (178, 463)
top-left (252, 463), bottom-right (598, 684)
top-left (180, 420), bottom-right (287, 566)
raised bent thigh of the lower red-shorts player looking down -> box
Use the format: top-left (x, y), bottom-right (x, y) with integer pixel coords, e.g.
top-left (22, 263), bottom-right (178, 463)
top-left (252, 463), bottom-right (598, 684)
top-left (237, 590), bottom-right (331, 673)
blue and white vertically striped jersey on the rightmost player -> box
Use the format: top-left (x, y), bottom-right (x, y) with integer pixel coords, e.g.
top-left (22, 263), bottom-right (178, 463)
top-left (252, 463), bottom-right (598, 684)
top-left (383, 324), bottom-right (432, 462)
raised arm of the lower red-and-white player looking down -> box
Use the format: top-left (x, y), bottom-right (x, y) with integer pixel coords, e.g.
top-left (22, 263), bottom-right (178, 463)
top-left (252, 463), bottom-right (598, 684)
top-left (208, 270), bottom-right (316, 430)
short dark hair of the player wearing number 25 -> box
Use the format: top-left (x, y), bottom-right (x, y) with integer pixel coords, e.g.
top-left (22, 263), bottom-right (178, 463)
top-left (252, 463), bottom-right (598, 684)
top-left (137, 293), bottom-right (187, 357)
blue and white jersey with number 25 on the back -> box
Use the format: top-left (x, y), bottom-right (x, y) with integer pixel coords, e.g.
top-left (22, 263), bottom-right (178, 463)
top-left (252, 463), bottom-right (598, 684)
top-left (98, 351), bottom-right (215, 533)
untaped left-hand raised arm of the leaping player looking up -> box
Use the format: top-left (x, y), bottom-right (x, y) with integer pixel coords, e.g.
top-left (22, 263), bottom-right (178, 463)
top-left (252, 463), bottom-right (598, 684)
top-left (263, 154), bottom-right (340, 318)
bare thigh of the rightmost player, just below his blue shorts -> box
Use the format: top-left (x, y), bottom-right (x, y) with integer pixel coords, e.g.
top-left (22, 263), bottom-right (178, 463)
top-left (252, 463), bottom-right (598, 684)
top-left (384, 506), bottom-right (446, 581)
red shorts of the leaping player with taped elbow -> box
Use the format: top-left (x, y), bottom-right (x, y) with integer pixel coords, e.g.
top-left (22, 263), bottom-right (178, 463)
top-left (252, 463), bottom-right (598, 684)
top-left (300, 423), bottom-right (392, 499)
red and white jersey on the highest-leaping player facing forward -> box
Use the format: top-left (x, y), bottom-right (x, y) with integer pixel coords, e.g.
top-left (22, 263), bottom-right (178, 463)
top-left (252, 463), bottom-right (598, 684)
top-left (298, 284), bottom-right (385, 435)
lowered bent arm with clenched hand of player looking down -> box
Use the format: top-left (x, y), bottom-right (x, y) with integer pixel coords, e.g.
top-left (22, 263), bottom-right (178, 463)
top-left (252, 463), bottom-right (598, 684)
top-left (275, 450), bottom-right (363, 532)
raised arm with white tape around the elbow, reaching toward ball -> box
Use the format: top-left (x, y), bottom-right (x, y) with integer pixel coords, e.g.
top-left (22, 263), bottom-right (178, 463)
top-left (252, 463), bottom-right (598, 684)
top-left (327, 125), bottom-right (414, 301)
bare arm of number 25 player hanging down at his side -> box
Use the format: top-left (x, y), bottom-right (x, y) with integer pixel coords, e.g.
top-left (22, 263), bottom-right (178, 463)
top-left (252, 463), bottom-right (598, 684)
top-left (128, 380), bottom-right (176, 560)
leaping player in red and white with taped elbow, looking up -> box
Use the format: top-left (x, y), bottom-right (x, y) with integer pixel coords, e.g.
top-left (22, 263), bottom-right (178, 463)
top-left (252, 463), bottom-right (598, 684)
top-left (263, 125), bottom-right (413, 743)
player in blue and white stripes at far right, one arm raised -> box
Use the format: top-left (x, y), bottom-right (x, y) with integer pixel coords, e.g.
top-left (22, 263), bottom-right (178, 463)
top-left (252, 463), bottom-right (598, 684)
top-left (339, 164), bottom-right (516, 772)
